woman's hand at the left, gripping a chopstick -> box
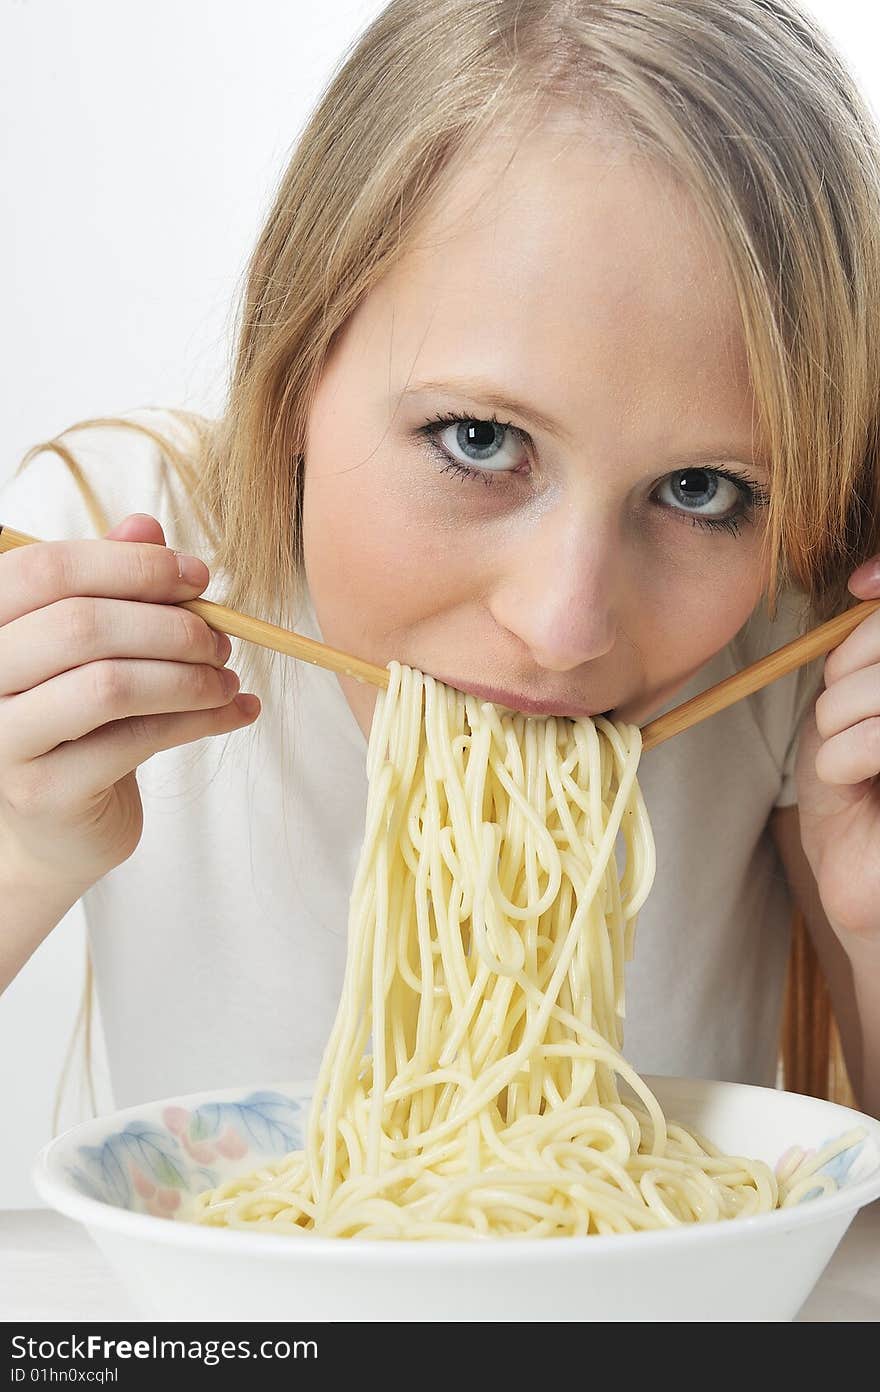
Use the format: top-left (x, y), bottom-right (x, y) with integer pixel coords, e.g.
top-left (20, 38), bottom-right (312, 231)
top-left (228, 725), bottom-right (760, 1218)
top-left (0, 514), bottom-right (260, 902)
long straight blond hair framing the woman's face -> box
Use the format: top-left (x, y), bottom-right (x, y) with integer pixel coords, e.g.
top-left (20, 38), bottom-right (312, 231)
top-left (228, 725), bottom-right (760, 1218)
top-left (22, 0), bottom-right (880, 1113)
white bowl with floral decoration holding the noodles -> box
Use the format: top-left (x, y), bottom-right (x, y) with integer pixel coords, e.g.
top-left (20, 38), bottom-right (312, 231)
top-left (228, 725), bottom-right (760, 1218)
top-left (33, 1077), bottom-right (880, 1322)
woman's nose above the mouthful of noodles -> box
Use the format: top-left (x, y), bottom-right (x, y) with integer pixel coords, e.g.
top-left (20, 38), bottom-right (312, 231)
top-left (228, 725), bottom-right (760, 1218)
top-left (490, 512), bottom-right (621, 672)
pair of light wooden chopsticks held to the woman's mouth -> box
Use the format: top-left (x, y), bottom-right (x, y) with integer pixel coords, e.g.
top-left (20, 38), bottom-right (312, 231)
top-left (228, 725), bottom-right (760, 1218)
top-left (0, 523), bottom-right (880, 750)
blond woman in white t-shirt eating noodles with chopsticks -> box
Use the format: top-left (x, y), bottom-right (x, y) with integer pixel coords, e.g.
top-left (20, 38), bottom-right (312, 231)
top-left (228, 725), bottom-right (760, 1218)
top-left (0, 0), bottom-right (880, 1108)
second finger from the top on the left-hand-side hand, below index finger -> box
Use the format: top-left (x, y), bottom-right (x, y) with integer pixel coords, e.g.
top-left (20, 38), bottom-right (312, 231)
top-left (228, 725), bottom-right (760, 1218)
top-left (0, 596), bottom-right (233, 696)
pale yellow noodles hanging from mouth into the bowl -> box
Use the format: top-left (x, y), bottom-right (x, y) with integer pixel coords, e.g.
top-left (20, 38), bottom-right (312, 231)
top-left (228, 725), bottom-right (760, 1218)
top-left (188, 663), bottom-right (852, 1239)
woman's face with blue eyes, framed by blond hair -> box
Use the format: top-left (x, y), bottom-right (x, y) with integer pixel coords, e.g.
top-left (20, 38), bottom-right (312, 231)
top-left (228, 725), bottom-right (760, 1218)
top-left (304, 125), bottom-right (767, 734)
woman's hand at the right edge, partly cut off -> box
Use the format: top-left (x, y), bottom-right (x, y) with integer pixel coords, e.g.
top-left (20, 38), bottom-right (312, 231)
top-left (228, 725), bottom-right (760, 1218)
top-left (795, 555), bottom-right (880, 945)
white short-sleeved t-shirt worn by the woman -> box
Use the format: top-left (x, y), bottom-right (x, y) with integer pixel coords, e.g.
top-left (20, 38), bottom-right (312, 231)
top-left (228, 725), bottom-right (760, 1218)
top-left (0, 411), bottom-right (822, 1107)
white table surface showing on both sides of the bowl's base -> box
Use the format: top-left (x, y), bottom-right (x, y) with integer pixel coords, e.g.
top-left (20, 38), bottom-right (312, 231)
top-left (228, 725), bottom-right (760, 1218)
top-left (0, 1200), bottom-right (880, 1324)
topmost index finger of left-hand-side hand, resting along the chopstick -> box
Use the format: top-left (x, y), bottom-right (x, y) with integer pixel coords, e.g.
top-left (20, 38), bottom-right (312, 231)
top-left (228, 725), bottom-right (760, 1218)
top-left (0, 539), bottom-right (210, 625)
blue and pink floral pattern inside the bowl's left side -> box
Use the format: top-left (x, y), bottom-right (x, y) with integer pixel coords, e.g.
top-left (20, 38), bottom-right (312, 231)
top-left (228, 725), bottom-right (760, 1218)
top-left (68, 1091), bottom-right (302, 1218)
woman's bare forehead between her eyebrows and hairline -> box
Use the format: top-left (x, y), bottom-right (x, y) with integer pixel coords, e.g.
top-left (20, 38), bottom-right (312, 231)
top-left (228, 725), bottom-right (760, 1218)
top-left (330, 129), bottom-right (752, 464)
